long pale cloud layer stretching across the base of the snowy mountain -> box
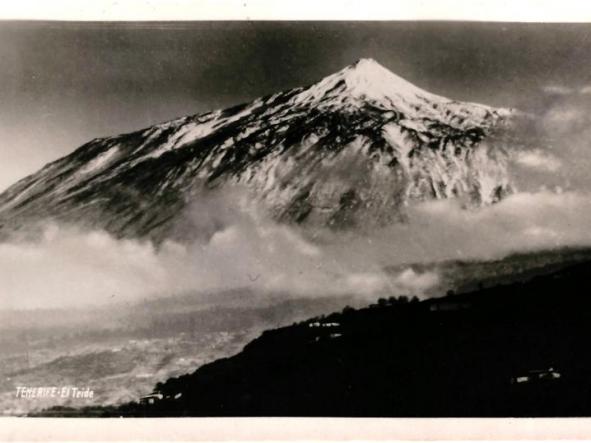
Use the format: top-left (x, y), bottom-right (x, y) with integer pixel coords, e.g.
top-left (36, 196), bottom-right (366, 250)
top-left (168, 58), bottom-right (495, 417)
top-left (0, 186), bottom-right (591, 308)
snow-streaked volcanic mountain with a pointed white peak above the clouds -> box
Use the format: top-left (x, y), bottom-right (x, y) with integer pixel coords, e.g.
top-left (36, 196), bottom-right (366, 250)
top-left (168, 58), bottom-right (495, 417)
top-left (0, 59), bottom-right (512, 240)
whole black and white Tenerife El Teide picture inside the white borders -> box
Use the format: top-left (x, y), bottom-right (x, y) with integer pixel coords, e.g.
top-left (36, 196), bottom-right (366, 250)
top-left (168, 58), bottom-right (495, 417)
top-left (0, 0), bottom-right (591, 438)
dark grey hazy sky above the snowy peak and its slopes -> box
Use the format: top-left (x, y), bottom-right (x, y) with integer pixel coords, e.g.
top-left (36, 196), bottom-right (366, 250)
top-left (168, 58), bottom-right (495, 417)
top-left (0, 22), bottom-right (591, 189)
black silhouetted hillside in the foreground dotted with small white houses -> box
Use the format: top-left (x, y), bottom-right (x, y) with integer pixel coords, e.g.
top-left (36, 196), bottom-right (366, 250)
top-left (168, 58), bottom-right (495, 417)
top-left (53, 262), bottom-right (591, 417)
